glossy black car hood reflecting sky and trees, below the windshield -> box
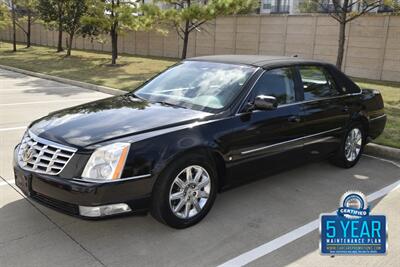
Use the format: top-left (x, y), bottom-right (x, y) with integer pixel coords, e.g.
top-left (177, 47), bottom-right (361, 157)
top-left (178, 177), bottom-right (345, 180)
top-left (30, 95), bottom-right (212, 147)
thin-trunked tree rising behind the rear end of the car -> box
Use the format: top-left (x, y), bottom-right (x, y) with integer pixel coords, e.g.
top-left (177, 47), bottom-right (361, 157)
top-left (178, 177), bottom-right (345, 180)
top-left (310, 0), bottom-right (382, 69)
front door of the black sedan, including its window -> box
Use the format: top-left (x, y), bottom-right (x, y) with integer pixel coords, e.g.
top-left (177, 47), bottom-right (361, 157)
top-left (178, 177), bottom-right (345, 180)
top-left (224, 67), bottom-right (304, 185)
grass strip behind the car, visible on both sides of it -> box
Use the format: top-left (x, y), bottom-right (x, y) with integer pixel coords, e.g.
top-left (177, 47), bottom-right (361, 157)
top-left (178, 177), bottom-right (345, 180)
top-left (0, 43), bottom-right (400, 148)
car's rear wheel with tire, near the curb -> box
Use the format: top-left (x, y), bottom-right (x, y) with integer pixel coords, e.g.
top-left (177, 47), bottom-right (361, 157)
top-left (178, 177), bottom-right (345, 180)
top-left (334, 123), bottom-right (365, 168)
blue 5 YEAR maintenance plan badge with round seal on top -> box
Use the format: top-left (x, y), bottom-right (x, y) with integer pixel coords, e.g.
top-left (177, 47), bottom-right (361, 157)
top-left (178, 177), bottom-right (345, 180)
top-left (320, 191), bottom-right (387, 255)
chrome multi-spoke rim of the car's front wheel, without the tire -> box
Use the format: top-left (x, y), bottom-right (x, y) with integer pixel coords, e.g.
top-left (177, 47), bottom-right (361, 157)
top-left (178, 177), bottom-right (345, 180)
top-left (169, 165), bottom-right (211, 219)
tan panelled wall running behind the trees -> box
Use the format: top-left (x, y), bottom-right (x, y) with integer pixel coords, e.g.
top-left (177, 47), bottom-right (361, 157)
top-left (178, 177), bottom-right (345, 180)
top-left (0, 14), bottom-right (400, 81)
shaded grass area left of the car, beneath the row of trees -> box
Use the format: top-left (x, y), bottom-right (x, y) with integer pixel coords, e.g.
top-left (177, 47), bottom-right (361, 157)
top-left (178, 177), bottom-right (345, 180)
top-left (0, 43), bottom-right (176, 91)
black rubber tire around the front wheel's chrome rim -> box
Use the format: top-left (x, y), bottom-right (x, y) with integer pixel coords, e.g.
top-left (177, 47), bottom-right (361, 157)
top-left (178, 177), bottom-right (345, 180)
top-left (150, 154), bottom-right (218, 229)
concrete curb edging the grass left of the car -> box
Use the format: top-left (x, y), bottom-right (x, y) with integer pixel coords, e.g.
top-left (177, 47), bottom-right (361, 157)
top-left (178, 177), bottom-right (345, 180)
top-left (0, 65), bottom-right (127, 95)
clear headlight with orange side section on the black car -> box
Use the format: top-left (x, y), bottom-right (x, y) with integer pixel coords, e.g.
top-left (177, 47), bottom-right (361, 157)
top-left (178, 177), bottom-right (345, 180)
top-left (82, 143), bottom-right (130, 181)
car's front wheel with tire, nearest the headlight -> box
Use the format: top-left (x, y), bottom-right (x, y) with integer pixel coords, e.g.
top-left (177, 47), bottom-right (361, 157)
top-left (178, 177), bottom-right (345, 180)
top-left (151, 154), bottom-right (217, 228)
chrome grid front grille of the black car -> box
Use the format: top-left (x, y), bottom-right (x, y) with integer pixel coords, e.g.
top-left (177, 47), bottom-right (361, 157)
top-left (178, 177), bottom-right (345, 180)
top-left (18, 131), bottom-right (76, 175)
